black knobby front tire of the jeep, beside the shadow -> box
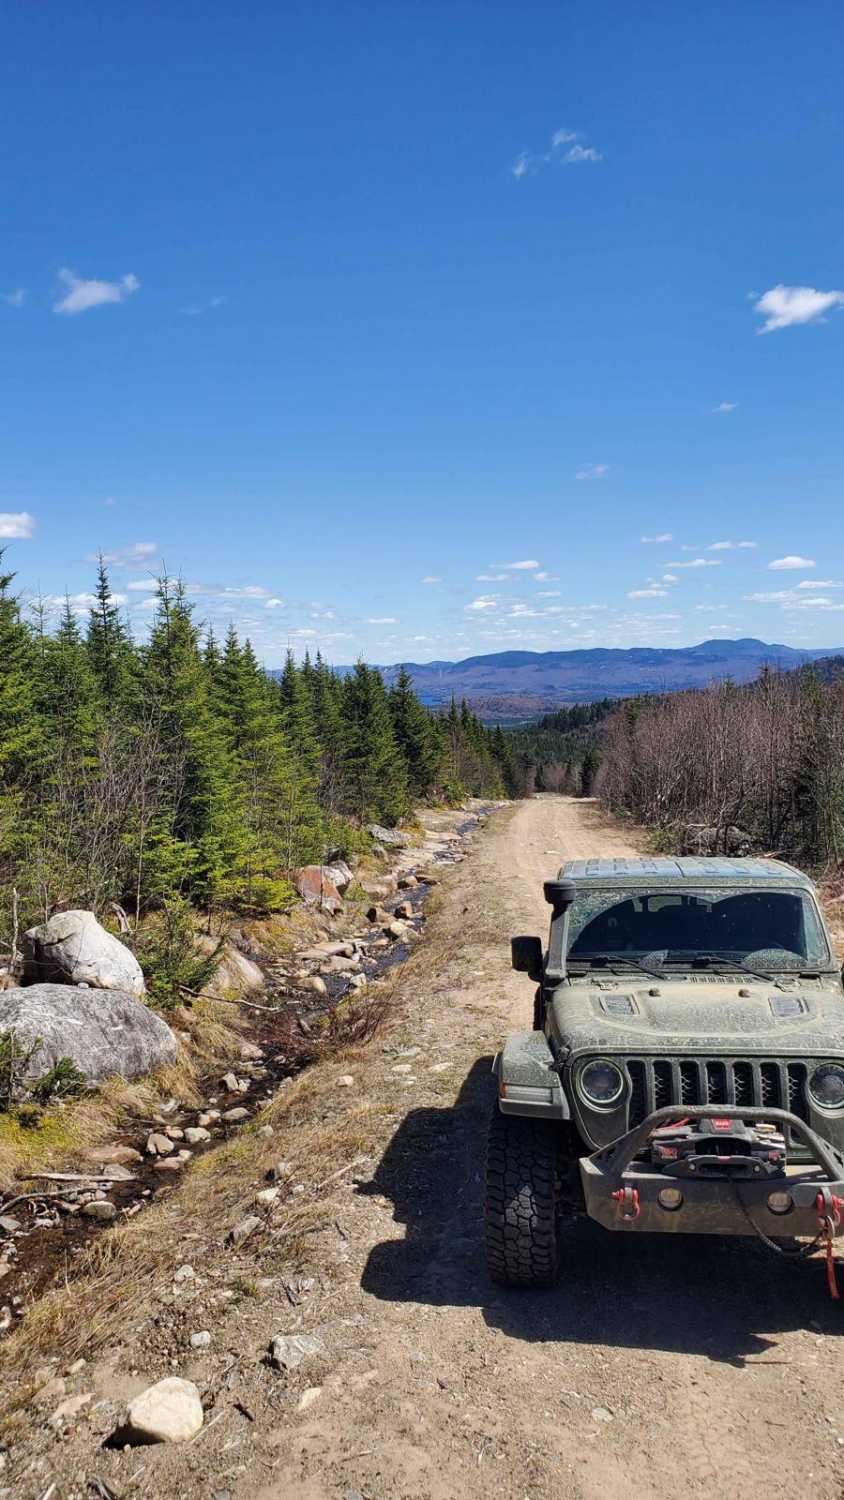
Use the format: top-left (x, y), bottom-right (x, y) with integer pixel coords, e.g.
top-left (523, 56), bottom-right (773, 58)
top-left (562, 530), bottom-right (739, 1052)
top-left (486, 1109), bottom-right (561, 1287)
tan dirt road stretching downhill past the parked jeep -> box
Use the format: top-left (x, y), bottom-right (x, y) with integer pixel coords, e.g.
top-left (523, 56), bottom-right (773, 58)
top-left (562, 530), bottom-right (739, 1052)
top-left (16, 798), bottom-right (844, 1500)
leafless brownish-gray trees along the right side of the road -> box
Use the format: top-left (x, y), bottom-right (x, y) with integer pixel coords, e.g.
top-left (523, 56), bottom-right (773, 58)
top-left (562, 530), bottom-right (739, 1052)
top-left (598, 668), bottom-right (844, 866)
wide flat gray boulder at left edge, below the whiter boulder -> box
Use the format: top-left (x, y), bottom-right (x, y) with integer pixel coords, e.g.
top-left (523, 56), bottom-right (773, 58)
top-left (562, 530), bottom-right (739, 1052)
top-left (0, 984), bottom-right (177, 1083)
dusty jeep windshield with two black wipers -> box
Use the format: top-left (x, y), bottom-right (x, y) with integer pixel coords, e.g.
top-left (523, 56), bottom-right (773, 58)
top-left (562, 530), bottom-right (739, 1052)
top-left (567, 885), bottom-right (832, 974)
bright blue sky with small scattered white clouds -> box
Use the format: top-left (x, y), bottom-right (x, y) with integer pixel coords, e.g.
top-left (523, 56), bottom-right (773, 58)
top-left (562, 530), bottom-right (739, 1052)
top-left (0, 0), bottom-right (844, 666)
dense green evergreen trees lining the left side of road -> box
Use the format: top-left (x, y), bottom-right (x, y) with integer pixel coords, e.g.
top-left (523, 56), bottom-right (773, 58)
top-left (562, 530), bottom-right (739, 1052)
top-left (0, 564), bottom-right (516, 944)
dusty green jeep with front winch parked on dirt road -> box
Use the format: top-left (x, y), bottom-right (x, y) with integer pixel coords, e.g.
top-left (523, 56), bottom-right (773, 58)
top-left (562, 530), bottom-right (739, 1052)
top-left (486, 858), bottom-right (844, 1287)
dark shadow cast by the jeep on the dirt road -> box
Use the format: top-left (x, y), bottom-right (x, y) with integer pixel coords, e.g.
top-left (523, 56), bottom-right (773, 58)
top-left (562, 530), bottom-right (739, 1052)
top-left (357, 1058), bottom-right (841, 1365)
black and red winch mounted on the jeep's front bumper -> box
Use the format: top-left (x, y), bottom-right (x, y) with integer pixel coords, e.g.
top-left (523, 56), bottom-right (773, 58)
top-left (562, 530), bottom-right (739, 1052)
top-left (646, 1116), bottom-right (786, 1178)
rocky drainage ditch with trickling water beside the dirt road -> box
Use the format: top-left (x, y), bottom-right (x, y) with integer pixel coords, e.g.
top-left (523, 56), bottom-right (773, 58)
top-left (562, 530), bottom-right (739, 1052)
top-left (0, 804), bottom-right (492, 1335)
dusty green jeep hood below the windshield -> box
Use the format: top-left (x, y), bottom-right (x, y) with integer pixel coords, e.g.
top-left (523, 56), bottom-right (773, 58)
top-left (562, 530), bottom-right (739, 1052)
top-left (552, 975), bottom-right (844, 1056)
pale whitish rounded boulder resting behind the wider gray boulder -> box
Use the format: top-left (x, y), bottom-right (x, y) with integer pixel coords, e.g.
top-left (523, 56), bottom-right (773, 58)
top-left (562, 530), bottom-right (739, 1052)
top-left (22, 912), bottom-right (144, 995)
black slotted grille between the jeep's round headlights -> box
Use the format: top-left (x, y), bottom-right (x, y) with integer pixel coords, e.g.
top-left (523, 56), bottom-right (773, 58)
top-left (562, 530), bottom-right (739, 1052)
top-left (627, 1058), bottom-right (808, 1130)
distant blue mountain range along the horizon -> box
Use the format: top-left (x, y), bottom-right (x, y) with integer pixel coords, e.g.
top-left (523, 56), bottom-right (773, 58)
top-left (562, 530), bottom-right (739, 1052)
top-left (368, 638), bottom-right (844, 723)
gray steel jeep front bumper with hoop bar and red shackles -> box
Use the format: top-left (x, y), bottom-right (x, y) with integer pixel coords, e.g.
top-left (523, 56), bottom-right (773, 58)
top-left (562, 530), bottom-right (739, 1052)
top-left (580, 1104), bottom-right (844, 1238)
